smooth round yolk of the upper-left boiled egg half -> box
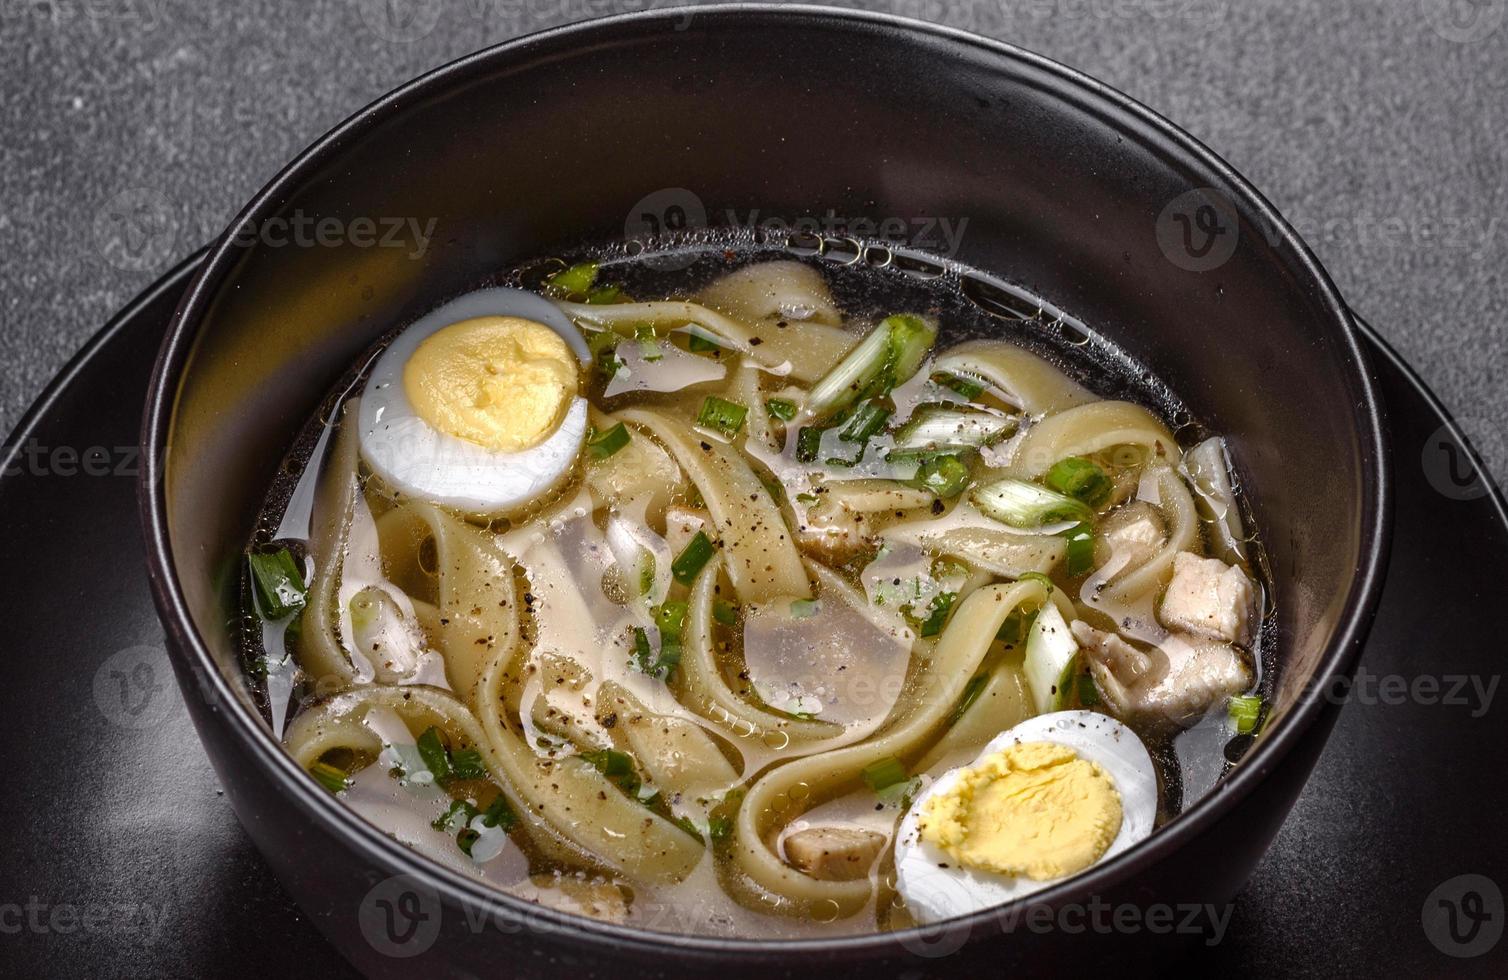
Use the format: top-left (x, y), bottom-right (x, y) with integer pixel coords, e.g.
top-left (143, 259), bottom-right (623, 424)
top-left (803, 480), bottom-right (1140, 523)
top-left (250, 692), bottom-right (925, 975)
top-left (403, 317), bottom-right (578, 452)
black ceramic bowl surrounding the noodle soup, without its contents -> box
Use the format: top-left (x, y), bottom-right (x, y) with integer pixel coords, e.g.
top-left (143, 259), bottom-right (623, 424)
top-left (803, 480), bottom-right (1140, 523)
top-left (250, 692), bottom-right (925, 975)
top-left (142, 6), bottom-right (1389, 977)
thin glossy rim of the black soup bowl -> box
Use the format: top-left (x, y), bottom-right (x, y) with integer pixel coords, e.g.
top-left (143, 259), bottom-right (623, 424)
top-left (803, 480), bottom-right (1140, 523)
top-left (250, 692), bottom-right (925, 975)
top-left (139, 3), bottom-right (1392, 962)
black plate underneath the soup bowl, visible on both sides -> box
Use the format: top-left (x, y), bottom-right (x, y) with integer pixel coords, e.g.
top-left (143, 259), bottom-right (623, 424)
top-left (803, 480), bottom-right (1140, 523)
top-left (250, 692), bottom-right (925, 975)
top-left (0, 256), bottom-right (1508, 977)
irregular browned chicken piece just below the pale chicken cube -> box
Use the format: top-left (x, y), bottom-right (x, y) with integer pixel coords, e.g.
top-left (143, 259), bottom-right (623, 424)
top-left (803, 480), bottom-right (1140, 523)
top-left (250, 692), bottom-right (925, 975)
top-left (1071, 620), bottom-right (1252, 727)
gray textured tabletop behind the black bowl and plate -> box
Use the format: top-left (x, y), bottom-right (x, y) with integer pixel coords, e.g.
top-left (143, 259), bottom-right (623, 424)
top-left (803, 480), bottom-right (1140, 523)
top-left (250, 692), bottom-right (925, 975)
top-left (0, 0), bottom-right (1508, 478)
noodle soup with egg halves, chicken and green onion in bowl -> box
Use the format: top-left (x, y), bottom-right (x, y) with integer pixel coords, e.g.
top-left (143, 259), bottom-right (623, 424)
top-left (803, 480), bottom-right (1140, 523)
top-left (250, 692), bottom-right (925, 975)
top-left (243, 256), bottom-right (1267, 938)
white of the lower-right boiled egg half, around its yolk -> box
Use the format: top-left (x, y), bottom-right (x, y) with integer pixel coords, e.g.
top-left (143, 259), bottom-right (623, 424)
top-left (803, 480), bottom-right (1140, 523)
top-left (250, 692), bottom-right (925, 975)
top-left (896, 712), bottom-right (1158, 923)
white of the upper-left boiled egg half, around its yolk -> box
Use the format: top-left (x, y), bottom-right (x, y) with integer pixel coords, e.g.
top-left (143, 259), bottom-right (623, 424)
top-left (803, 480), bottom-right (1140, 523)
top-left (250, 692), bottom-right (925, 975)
top-left (357, 288), bottom-right (591, 516)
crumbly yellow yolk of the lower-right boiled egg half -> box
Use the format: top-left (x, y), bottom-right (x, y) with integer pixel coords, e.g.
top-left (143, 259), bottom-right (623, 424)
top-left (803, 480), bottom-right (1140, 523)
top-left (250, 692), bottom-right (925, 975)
top-left (918, 742), bottom-right (1120, 880)
